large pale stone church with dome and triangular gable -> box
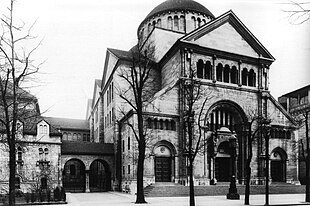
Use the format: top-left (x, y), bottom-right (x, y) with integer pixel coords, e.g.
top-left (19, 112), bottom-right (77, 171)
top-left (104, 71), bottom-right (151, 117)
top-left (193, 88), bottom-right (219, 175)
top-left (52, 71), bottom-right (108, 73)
top-left (88, 0), bottom-right (298, 193)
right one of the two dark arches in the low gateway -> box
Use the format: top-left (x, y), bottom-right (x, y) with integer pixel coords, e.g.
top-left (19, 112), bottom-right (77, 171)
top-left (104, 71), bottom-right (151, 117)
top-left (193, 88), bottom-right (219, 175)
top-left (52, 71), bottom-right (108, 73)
top-left (89, 160), bottom-right (111, 192)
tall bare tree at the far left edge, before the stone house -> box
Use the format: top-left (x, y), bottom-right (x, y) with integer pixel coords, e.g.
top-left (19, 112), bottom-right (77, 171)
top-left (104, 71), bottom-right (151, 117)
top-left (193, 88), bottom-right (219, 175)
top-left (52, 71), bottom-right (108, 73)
top-left (0, 0), bottom-right (39, 205)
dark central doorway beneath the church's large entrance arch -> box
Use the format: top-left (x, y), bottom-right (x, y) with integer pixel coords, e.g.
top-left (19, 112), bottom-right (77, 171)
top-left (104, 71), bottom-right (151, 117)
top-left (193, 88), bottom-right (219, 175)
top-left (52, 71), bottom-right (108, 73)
top-left (215, 141), bottom-right (231, 182)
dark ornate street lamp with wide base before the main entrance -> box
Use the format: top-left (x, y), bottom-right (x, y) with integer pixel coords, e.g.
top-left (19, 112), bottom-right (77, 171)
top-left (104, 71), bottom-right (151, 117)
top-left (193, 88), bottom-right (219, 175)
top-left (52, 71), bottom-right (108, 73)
top-left (226, 135), bottom-right (240, 200)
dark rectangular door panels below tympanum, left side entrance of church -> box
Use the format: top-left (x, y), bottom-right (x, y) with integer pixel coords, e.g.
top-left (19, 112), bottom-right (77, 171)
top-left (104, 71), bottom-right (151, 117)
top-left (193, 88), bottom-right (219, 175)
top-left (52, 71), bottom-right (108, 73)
top-left (155, 157), bottom-right (171, 182)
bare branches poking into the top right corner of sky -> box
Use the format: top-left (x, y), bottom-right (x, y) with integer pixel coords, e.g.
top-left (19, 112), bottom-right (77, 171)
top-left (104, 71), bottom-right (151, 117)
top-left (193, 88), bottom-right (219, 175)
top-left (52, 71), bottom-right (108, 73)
top-left (283, 1), bottom-right (310, 24)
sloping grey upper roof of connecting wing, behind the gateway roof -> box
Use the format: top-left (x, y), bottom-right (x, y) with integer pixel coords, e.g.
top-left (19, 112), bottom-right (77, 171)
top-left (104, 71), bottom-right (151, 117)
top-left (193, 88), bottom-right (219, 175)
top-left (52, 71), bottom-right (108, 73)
top-left (43, 117), bottom-right (89, 130)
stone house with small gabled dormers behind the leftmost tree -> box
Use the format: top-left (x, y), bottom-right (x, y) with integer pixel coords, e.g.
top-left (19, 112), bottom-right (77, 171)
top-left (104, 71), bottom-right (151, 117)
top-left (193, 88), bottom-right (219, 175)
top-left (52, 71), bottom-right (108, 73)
top-left (0, 88), bottom-right (61, 194)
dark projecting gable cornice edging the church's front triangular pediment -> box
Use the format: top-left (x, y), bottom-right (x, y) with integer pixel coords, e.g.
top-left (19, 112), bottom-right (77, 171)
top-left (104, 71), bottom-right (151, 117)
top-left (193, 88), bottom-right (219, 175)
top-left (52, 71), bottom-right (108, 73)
top-left (180, 10), bottom-right (275, 61)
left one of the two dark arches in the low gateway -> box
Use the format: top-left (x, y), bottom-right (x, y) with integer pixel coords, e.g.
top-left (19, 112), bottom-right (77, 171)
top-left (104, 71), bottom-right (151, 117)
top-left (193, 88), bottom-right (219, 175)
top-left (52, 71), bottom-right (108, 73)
top-left (62, 159), bottom-right (85, 192)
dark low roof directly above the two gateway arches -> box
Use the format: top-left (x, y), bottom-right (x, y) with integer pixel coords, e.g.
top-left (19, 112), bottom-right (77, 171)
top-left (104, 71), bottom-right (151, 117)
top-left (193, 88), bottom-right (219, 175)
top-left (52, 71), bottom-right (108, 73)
top-left (61, 141), bottom-right (114, 155)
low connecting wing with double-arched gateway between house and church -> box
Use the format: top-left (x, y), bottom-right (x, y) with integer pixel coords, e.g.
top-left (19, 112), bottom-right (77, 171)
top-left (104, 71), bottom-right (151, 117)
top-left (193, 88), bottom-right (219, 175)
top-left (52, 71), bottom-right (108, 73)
top-left (44, 117), bottom-right (115, 192)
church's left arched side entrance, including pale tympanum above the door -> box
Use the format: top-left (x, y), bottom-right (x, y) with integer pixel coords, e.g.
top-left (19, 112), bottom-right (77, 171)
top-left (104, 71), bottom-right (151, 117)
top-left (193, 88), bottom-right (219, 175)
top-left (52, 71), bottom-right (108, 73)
top-left (154, 145), bottom-right (172, 182)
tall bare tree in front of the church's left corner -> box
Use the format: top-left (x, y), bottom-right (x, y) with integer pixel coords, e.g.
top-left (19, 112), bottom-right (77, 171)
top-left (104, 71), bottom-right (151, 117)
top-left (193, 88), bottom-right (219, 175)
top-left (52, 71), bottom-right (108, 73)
top-left (119, 44), bottom-right (156, 203)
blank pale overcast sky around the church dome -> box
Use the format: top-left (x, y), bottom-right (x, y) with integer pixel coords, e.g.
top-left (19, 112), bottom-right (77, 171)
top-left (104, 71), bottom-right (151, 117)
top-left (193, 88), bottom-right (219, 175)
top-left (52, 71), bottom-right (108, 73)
top-left (0, 0), bottom-right (310, 119)
